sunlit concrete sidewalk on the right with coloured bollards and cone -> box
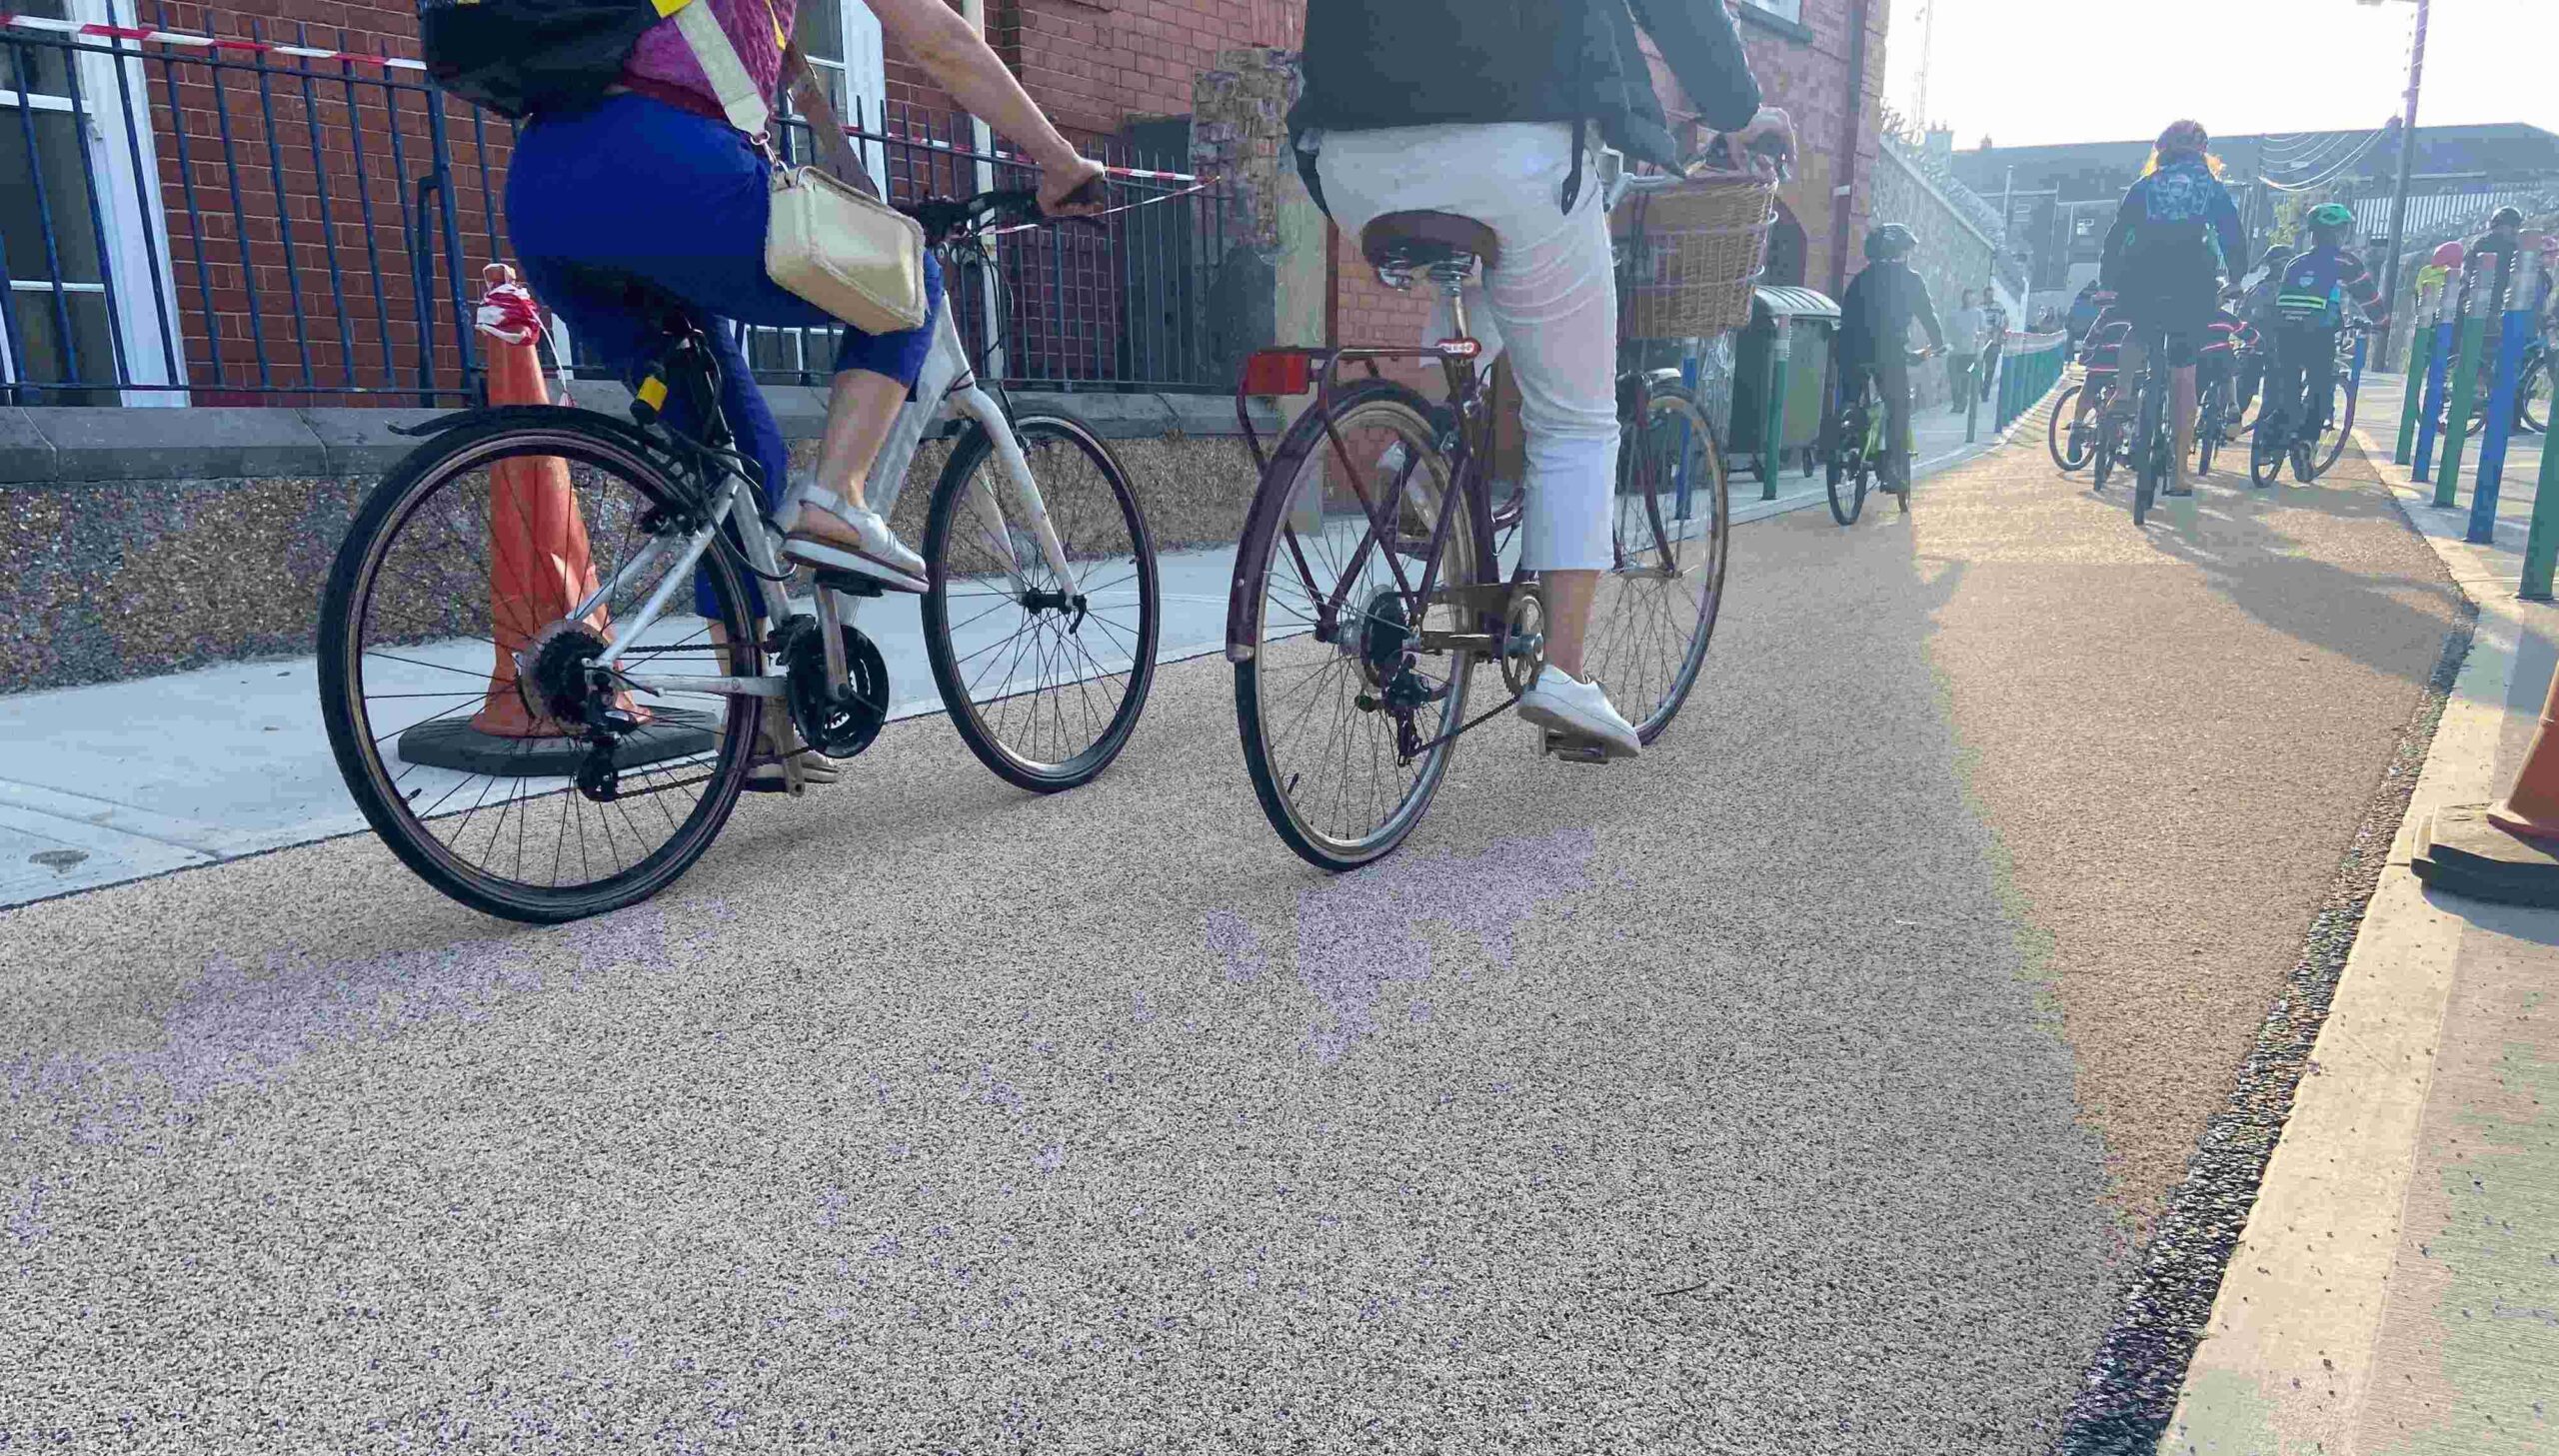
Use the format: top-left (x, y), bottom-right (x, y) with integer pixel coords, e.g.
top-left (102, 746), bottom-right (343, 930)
top-left (2160, 409), bottom-right (2559, 1456)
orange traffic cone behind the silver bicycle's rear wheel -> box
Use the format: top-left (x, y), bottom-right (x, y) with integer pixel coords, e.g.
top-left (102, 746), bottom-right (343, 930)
top-left (471, 264), bottom-right (624, 736)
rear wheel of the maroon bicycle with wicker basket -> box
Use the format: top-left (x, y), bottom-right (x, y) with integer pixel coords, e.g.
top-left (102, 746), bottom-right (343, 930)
top-left (1229, 379), bottom-right (1479, 870)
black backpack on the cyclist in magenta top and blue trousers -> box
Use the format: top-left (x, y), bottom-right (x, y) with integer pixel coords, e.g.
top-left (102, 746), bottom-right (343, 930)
top-left (417, 0), bottom-right (670, 118)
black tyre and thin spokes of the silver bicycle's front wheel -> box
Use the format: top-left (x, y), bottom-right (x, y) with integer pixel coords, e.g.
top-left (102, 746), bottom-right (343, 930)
top-left (922, 415), bottom-right (1165, 793)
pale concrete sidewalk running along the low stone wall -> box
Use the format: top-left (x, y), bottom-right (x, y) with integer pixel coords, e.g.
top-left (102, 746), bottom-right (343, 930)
top-left (0, 391), bottom-right (1998, 905)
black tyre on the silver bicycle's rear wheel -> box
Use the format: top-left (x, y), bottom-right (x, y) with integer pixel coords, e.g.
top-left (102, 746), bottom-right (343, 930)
top-left (317, 410), bottom-right (763, 923)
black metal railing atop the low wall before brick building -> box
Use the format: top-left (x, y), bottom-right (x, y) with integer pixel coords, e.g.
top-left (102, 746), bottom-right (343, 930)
top-left (0, 11), bottom-right (1226, 405)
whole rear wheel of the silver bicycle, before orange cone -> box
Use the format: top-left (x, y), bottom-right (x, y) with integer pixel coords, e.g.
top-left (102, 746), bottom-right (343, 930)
top-left (320, 410), bottom-right (763, 923)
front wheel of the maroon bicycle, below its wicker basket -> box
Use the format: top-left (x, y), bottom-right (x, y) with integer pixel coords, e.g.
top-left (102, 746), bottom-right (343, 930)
top-left (1584, 384), bottom-right (1732, 742)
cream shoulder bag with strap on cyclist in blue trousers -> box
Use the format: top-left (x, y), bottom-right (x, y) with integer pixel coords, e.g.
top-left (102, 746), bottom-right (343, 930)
top-left (676, 0), bottom-right (927, 333)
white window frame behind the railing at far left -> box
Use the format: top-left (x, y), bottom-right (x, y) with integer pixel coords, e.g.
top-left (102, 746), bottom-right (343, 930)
top-left (0, 0), bottom-right (185, 407)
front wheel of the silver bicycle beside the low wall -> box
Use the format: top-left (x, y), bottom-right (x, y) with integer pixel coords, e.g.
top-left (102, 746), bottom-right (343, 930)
top-left (924, 415), bottom-right (1162, 793)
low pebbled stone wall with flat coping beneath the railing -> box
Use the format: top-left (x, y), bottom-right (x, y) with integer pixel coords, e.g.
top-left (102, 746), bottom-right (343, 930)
top-left (0, 384), bottom-right (1280, 694)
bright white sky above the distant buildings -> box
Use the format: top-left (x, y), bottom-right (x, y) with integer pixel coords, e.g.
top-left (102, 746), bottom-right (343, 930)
top-left (1883, 0), bottom-right (2559, 149)
